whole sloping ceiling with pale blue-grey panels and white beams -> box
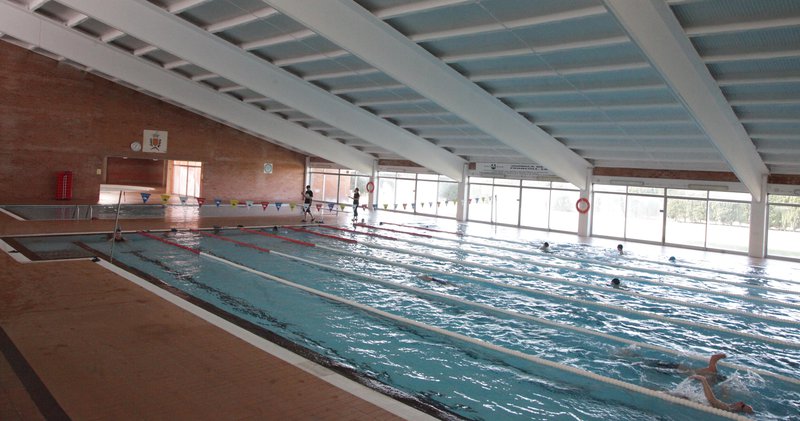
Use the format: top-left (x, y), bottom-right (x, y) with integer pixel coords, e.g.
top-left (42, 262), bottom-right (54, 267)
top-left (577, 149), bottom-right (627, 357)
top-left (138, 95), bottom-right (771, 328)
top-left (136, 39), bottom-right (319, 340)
top-left (0, 0), bottom-right (800, 192)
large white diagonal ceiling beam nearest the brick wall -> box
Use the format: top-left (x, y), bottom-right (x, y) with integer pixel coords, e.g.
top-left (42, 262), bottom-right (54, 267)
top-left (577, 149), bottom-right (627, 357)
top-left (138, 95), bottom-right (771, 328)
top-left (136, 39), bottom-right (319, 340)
top-left (0, 2), bottom-right (374, 173)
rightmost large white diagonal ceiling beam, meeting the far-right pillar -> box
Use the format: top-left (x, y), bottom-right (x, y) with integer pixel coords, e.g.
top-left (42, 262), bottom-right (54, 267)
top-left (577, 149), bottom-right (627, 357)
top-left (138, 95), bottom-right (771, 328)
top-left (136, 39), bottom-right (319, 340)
top-left (604, 0), bottom-right (769, 200)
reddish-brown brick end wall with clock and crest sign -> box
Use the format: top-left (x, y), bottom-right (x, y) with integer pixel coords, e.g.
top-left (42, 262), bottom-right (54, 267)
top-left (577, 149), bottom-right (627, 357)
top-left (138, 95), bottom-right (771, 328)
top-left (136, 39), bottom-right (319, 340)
top-left (0, 42), bottom-right (305, 203)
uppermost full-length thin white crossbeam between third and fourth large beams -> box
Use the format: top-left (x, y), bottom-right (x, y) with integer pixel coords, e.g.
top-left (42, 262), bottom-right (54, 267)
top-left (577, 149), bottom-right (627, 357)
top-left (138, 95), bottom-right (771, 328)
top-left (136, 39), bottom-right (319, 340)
top-left (410, 5), bottom-right (608, 42)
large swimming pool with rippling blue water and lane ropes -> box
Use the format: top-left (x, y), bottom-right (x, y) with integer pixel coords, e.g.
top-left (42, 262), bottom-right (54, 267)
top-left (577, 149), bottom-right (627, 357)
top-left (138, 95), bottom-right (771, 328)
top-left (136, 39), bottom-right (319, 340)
top-left (6, 223), bottom-right (800, 420)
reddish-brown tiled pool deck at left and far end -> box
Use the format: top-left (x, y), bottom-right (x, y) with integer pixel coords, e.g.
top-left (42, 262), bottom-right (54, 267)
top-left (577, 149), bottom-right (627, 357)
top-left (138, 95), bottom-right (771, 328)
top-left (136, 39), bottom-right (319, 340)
top-left (0, 208), bottom-right (410, 421)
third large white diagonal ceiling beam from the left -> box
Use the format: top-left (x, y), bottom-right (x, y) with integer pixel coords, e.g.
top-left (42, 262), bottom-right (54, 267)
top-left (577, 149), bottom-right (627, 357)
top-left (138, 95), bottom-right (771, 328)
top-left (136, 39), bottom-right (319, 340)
top-left (270, 0), bottom-right (592, 188)
